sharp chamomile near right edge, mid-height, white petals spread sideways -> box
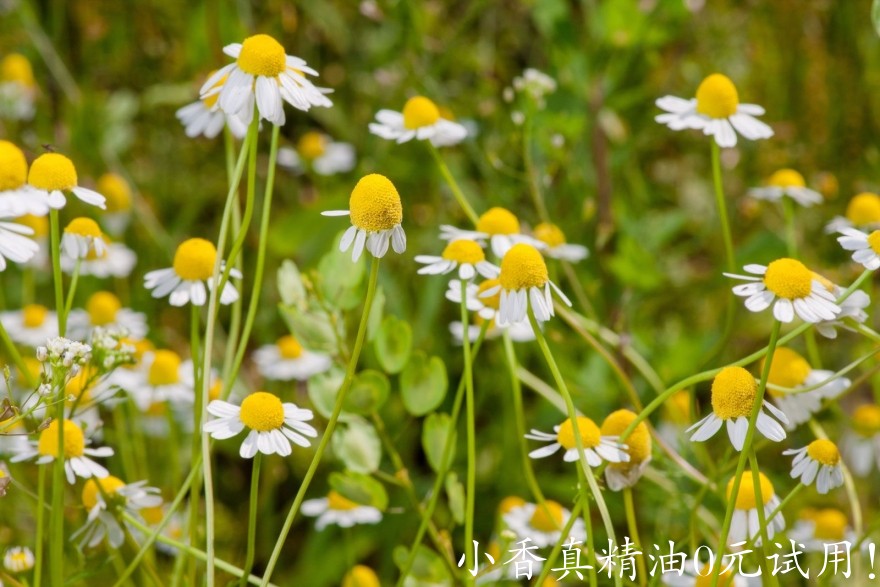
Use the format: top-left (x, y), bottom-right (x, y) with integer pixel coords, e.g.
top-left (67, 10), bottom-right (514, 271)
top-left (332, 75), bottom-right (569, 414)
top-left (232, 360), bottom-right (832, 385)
top-left (724, 258), bottom-right (840, 324)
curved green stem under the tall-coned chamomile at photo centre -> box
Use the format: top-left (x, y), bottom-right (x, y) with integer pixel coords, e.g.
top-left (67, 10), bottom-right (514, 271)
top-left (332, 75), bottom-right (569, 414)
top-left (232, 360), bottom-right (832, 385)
top-left (262, 257), bottom-right (380, 587)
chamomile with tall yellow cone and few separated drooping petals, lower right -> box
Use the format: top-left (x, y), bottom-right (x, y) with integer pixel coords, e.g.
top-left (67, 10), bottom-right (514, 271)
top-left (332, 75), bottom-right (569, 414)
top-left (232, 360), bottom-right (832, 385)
top-left (687, 367), bottom-right (788, 451)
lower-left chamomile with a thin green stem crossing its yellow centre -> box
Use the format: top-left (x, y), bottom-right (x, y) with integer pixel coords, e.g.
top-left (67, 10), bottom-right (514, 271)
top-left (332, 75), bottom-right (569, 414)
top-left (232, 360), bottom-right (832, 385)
top-left (9, 420), bottom-right (113, 485)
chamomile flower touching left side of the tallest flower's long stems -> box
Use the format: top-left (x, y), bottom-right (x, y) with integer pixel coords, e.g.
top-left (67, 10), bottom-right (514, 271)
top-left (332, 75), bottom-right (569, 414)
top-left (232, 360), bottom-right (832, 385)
top-left (144, 238), bottom-right (241, 306)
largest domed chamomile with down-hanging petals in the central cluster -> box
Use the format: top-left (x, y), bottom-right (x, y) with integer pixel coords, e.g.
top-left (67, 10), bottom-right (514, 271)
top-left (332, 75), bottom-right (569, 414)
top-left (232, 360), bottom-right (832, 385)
top-left (482, 243), bottom-right (571, 326)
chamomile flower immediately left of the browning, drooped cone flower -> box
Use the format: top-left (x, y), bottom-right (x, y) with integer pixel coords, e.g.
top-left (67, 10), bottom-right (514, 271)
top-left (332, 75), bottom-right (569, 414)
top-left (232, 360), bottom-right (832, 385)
top-left (526, 416), bottom-right (630, 467)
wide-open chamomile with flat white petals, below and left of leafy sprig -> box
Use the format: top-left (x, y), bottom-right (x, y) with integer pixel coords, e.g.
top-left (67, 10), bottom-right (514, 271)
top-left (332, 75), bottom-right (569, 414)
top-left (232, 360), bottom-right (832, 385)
top-left (202, 391), bottom-right (318, 459)
